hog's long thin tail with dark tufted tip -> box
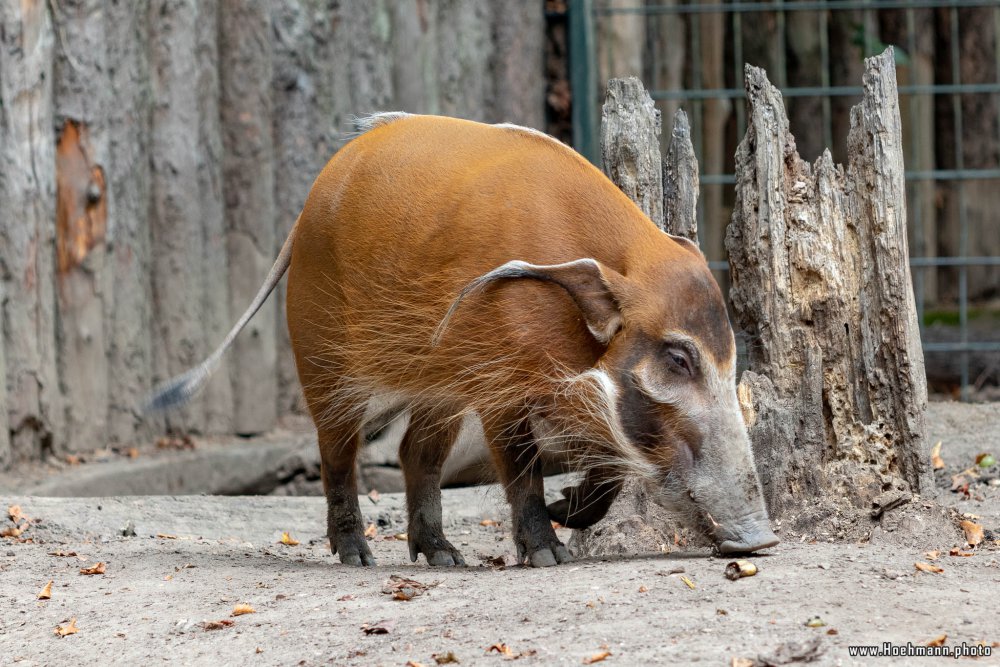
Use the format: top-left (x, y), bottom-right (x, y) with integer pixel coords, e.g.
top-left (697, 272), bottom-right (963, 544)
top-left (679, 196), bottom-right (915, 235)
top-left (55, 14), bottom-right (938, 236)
top-left (142, 214), bottom-right (302, 412)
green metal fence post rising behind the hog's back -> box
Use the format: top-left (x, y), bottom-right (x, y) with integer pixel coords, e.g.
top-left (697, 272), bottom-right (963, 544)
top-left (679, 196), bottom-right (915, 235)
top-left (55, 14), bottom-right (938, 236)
top-left (569, 0), bottom-right (601, 167)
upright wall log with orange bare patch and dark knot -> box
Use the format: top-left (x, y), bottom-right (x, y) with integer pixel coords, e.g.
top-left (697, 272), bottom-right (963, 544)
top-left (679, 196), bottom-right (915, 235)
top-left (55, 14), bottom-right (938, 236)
top-left (51, 0), bottom-right (114, 451)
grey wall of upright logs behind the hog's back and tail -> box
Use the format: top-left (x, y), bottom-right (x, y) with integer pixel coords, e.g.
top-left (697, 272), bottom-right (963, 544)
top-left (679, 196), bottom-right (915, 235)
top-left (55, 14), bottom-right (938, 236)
top-left (0, 0), bottom-right (545, 467)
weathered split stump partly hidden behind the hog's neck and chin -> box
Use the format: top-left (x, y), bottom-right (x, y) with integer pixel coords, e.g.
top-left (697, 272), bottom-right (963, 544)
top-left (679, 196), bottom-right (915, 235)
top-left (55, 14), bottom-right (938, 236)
top-left (569, 77), bottom-right (707, 556)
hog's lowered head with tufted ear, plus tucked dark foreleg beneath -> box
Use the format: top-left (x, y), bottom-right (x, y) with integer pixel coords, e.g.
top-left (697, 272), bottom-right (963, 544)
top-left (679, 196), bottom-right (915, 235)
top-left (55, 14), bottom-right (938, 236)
top-left (440, 235), bottom-right (778, 553)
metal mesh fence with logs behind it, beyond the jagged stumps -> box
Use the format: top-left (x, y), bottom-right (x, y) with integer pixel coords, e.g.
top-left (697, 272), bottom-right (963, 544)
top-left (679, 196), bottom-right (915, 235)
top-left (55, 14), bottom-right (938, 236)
top-left (569, 0), bottom-right (1000, 400)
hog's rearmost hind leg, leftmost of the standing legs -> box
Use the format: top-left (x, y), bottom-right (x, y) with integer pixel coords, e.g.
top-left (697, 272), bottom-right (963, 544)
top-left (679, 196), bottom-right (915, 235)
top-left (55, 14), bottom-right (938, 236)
top-left (318, 420), bottom-right (375, 566)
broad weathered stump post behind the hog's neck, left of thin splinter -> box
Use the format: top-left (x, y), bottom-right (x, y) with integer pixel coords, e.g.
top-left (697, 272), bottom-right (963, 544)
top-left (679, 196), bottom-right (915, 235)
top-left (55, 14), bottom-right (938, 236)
top-left (601, 76), bottom-right (663, 229)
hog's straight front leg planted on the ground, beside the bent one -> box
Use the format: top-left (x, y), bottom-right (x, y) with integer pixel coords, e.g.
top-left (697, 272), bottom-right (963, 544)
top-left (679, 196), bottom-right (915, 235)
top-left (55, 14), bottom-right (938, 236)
top-left (483, 413), bottom-right (573, 567)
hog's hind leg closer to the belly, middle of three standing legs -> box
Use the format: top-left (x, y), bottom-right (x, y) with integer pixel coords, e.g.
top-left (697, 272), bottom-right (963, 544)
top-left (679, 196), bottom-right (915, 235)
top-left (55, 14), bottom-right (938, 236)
top-left (399, 407), bottom-right (465, 566)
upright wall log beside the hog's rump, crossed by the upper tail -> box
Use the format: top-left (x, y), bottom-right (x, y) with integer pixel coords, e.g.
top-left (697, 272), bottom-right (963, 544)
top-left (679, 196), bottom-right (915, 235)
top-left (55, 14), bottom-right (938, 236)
top-left (219, 0), bottom-right (278, 434)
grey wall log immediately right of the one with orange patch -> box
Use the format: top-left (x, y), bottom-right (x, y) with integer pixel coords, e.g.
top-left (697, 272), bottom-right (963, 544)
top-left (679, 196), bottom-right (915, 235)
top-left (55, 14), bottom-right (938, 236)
top-left (104, 0), bottom-right (157, 444)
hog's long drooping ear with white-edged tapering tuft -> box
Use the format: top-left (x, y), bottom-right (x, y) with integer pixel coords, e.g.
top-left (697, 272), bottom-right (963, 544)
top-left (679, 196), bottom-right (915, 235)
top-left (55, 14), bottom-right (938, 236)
top-left (431, 258), bottom-right (624, 345)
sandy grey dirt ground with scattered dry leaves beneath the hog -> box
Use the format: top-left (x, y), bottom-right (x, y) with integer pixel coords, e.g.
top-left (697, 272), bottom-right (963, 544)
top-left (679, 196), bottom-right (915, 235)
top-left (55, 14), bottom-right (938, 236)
top-left (0, 404), bottom-right (1000, 665)
